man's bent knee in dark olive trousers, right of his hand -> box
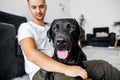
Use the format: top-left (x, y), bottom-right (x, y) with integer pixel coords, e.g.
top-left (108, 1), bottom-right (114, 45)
top-left (84, 60), bottom-right (120, 80)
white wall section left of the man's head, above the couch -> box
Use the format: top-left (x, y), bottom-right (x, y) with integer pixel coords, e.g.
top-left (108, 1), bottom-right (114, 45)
top-left (0, 0), bottom-right (31, 19)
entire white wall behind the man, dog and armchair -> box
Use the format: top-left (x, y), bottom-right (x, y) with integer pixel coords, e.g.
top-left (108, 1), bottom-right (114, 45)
top-left (0, 0), bottom-right (120, 34)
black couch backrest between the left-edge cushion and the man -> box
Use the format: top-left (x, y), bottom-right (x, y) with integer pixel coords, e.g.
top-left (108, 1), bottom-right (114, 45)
top-left (0, 11), bottom-right (27, 77)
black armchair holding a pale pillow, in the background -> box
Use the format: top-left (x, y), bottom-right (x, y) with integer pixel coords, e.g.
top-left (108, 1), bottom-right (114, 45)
top-left (87, 27), bottom-right (116, 47)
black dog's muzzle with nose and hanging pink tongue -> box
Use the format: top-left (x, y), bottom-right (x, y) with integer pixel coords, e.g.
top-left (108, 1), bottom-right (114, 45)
top-left (54, 36), bottom-right (72, 59)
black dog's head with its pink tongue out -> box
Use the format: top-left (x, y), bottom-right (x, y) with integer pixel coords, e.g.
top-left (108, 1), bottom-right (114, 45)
top-left (47, 18), bottom-right (83, 59)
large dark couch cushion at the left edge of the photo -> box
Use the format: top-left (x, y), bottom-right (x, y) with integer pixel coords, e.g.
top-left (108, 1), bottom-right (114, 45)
top-left (0, 22), bottom-right (17, 80)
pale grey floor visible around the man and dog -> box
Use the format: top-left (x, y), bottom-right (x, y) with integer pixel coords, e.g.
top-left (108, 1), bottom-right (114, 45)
top-left (12, 46), bottom-right (120, 80)
